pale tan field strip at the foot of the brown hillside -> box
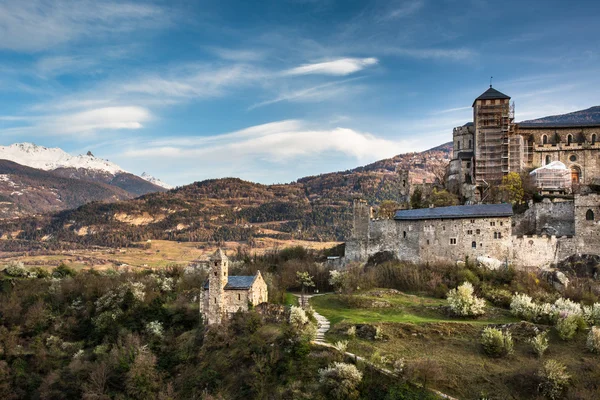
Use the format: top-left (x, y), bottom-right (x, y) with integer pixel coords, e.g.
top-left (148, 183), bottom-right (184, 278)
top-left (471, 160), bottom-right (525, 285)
top-left (0, 238), bottom-right (338, 269)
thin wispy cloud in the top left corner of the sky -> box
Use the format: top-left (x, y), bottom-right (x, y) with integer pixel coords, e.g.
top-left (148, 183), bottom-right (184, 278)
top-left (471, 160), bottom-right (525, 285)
top-left (0, 0), bottom-right (170, 52)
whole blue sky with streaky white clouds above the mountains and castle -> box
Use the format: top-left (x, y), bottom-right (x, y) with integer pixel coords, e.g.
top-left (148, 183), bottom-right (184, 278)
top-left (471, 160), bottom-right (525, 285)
top-left (0, 0), bottom-right (600, 185)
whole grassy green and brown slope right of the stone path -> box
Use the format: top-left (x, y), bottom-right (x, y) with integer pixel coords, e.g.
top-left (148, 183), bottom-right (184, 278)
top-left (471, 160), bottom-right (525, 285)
top-left (311, 290), bottom-right (600, 399)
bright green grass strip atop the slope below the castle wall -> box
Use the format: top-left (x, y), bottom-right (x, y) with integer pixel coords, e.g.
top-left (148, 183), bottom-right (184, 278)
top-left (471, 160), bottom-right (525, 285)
top-left (310, 293), bottom-right (518, 325)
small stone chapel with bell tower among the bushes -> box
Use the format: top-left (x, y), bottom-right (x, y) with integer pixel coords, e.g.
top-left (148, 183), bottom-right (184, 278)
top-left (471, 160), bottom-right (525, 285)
top-left (200, 249), bottom-right (268, 325)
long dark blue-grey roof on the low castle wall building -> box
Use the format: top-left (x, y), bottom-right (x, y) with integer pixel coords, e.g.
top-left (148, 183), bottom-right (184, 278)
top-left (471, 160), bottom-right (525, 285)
top-left (394, 204), bottom-right (513, 220)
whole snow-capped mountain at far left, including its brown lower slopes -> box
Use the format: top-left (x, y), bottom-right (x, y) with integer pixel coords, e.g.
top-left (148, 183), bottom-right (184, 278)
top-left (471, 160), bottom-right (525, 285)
top-left (0, 143), bottom-right (169, 219)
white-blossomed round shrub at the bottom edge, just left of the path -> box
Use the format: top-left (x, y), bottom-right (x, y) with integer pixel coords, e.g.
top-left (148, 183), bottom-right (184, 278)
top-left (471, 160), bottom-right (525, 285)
top-left (319, 362), bottom-right (362, 399)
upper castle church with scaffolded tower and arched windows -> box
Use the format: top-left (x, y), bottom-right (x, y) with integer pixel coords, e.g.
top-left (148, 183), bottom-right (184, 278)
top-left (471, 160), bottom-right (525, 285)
top-left (447, 85), bottom-right (600, 202)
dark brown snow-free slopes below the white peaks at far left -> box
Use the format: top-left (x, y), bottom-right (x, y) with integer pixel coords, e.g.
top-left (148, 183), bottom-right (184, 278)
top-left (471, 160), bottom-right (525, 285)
top-left (0, 160), bottom-right (132, 218)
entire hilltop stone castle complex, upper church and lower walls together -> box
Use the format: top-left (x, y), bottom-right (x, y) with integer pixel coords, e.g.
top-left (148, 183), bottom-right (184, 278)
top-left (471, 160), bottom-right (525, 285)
top-left (345, 86), bottom-right (600, 268)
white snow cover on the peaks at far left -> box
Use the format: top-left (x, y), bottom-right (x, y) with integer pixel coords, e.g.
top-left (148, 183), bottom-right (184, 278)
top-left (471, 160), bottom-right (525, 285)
top-left (0, 143), bottom-right (127, 175)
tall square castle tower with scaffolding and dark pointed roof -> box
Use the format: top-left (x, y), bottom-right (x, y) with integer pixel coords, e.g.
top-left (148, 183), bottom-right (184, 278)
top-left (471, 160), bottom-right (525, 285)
top-left (473, 85), bottom-right (513, 194)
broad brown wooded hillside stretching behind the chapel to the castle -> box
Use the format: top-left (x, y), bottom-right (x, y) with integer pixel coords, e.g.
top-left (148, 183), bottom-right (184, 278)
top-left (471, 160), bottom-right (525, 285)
top-left (0, 144), bottom-right (451, 246)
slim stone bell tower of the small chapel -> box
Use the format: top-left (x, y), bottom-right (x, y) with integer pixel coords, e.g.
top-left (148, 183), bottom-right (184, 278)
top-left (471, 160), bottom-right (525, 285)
top-left (205, 248), bottom-right (229, 325)
